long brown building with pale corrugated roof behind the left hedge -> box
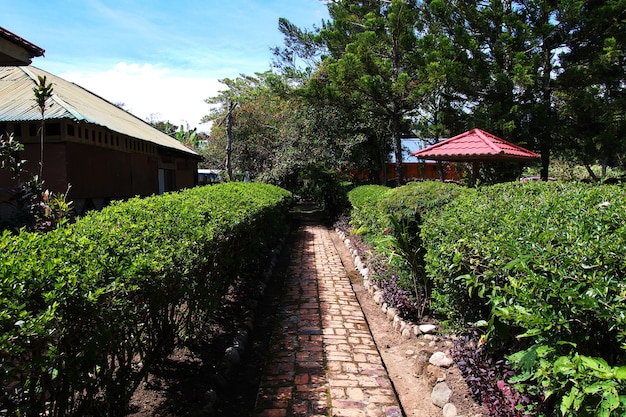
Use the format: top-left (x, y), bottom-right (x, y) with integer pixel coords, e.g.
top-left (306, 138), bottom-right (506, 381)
top-left (0, 66), bottom-right (200, 212)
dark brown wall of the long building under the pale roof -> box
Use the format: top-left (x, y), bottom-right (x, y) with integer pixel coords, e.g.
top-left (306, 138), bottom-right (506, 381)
top-left (0, 120), bottom-right (197, 211)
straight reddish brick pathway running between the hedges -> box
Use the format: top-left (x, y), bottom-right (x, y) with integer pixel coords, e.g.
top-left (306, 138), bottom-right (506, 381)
top-left (256, 224), bottom-right (402, 417)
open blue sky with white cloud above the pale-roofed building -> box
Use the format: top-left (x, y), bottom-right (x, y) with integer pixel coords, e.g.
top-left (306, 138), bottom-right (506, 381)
top-left (6, 0), bottom-right (328, 131)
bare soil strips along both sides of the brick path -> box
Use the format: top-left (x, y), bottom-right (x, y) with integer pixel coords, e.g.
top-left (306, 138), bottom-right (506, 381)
top-left (127, 211), bottom-right (488, 417)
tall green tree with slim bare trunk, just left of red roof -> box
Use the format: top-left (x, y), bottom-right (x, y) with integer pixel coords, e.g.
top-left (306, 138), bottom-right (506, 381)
top-left (310, 0), bottom-right (428, 184)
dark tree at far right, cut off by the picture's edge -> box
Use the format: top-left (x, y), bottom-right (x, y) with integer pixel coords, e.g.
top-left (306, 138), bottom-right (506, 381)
top-left (558, 0), bottom-right (626, 180)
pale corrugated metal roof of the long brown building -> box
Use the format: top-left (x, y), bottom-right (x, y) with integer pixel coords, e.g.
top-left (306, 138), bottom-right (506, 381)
top-left (0, 66), bottom-right (198, 156)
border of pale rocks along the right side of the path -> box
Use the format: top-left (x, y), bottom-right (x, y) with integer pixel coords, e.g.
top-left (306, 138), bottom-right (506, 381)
top-left (335, 227), bottom-right (482, 417)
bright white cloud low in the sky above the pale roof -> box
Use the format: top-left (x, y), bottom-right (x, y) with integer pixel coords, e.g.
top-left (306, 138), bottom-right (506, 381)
top-left (58, 62), bottom-right (226, 131)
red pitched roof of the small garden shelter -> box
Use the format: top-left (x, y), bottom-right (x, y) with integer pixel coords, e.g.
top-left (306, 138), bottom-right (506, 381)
top-left (413, 129), bottom-right (540, 162)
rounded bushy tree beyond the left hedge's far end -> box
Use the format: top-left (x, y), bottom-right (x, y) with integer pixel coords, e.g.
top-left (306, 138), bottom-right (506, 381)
top-left (204, 71), bottom-right (355, 184)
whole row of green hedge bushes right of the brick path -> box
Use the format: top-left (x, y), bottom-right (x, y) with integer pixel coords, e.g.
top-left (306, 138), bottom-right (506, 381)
top-left (350, 182), bottom-right (626, 417)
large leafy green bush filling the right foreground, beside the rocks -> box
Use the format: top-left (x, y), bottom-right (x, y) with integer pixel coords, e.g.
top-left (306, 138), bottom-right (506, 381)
top-left (422, 183), bottom-right (626, 416)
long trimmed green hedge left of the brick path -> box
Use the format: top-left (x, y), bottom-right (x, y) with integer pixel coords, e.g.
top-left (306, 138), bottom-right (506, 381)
top-left (0, 183), bottom-right (290, 416)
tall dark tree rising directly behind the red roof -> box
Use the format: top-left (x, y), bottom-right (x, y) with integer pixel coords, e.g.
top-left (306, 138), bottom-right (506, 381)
top-left (431, 0), bottom-right (566, 178)
